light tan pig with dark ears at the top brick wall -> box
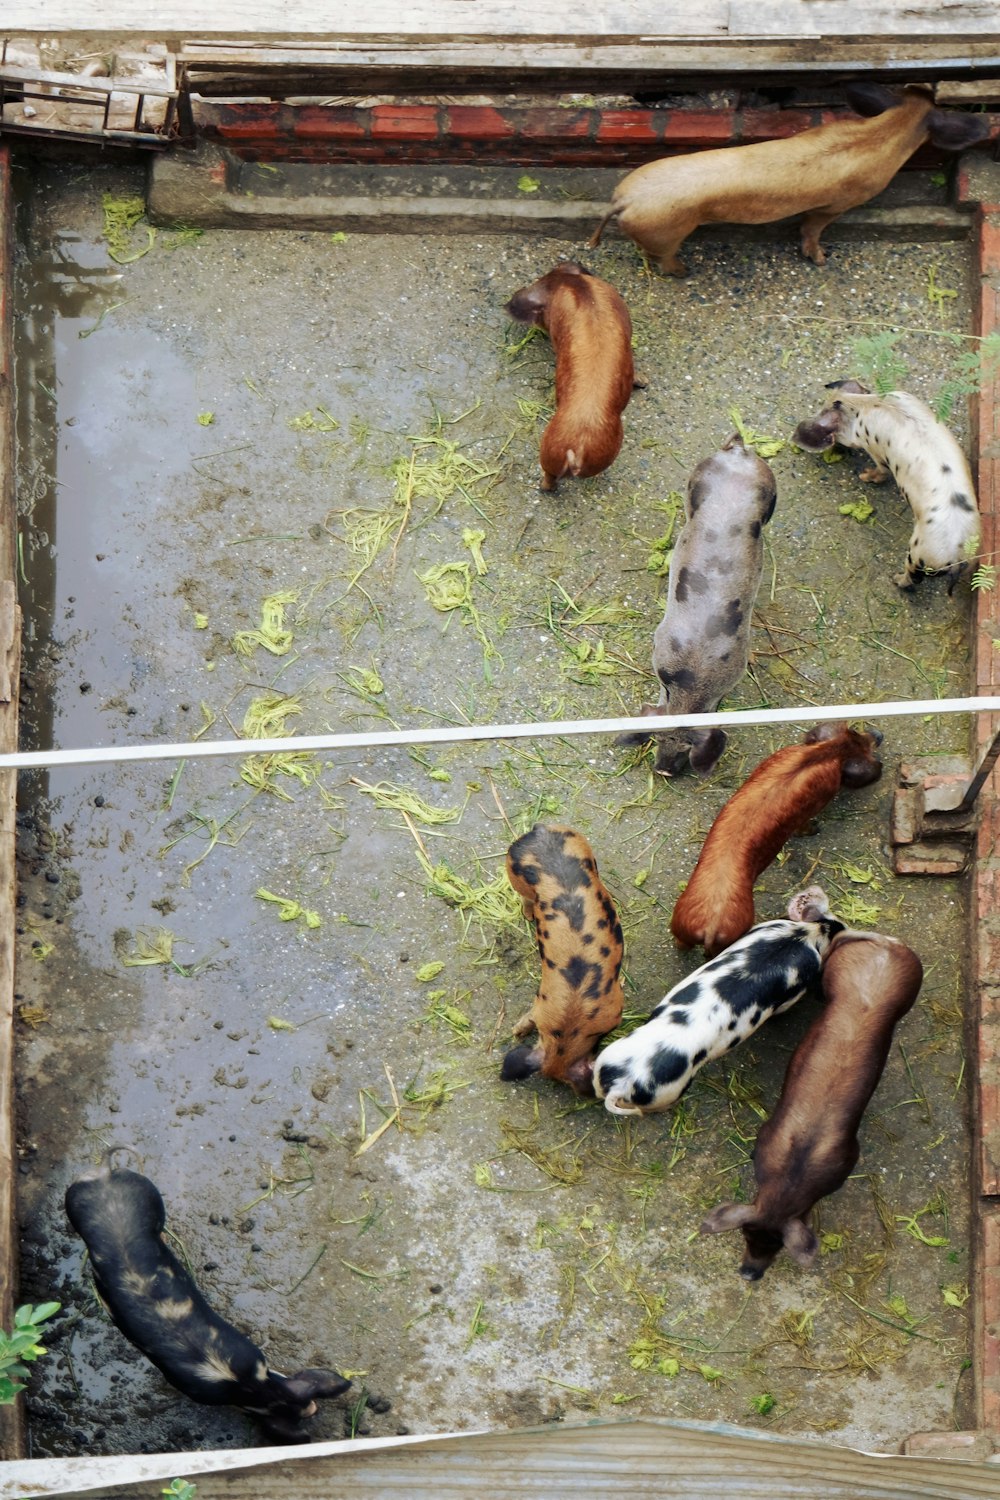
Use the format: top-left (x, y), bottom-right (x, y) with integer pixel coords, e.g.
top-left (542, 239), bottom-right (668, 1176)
top-left (588, 83), bottom-right (990, 276)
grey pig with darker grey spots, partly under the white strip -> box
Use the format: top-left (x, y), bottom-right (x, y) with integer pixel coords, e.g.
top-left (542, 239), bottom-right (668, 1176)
top-left (622, 434), bottom-right (775, 776)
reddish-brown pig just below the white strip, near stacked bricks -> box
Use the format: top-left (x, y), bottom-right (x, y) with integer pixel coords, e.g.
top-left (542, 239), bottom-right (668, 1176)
top-left (670, 723), bottom-right (882, 959)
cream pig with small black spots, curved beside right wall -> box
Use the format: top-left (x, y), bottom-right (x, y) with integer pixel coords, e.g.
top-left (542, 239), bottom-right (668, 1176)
top-left (792, 380), bottom-right (979, 594)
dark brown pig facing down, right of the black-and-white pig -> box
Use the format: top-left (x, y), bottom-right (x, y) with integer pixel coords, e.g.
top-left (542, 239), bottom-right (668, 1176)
top-left (702, 932), bottom-right (924, 1281)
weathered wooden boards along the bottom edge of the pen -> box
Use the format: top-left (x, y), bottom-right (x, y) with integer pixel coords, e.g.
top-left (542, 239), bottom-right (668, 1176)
top-left (9, 1418), bottom-right (997, 1500)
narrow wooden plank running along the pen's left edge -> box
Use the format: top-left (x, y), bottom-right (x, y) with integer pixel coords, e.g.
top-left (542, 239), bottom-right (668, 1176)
top-left (0, 147), bottom-right (24, 1460)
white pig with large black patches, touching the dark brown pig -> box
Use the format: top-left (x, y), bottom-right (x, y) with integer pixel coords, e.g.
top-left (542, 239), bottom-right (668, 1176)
top-left (594, 885), bottom-right (844, 1115)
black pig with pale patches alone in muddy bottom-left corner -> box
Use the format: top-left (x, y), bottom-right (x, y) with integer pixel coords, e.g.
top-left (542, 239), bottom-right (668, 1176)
top-left (66, 1166), bottom-right (351, 1443)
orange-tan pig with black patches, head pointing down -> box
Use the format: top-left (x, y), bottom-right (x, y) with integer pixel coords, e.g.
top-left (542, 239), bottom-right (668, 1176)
top-left (501, 824), bottom-right (624, 1097)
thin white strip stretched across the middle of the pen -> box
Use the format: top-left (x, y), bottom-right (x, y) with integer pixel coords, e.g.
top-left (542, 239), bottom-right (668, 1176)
top-left (0, 698), bottom-right (1000, 771)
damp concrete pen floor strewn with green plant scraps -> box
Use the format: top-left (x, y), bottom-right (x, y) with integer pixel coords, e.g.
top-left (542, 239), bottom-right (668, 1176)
top-left (7, 167), bottom-right (972, 1457)
